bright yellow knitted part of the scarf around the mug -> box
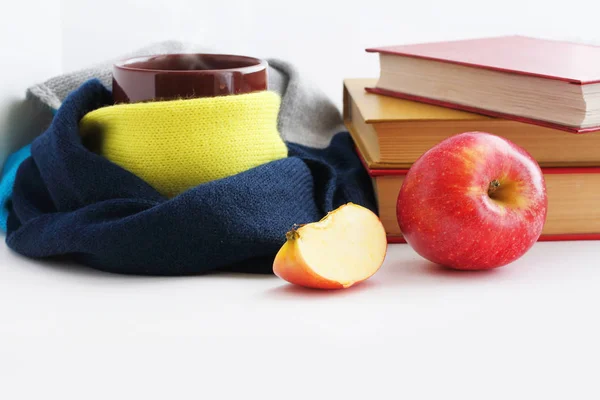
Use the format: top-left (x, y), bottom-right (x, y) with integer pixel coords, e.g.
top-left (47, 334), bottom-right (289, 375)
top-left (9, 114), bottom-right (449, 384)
top-left (80, 91), bottom-right (287, 197)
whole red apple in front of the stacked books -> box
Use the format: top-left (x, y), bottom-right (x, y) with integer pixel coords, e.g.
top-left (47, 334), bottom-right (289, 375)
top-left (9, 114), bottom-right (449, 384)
top-left (397, 132), bottom-right (548, 270)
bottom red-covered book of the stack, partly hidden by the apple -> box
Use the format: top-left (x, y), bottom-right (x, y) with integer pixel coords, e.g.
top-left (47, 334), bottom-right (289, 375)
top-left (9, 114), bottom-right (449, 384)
top-left (356, 149), bottom-right (600, 243)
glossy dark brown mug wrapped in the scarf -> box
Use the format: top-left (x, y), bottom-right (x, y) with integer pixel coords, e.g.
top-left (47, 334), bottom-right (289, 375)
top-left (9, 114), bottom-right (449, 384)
top-left (112, 54), bottom-right (268, 104)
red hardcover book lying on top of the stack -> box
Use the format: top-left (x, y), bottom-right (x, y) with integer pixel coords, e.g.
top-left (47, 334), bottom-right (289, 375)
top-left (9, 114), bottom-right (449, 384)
top-left (366, 36), bottom-right (600, 133)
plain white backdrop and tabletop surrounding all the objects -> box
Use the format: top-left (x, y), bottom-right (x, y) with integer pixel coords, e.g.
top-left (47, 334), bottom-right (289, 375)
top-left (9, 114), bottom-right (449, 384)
top-left (0, 0), bottom-right (600, 400)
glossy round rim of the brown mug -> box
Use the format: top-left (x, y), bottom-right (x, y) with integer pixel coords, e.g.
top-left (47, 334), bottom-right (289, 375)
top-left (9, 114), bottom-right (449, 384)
top-left (113, 53), bottom-right (268, 74)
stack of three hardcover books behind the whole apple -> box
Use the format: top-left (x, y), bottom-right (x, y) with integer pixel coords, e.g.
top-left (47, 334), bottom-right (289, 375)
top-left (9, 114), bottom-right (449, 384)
top-left (343, 36), bottom-right (600, 242)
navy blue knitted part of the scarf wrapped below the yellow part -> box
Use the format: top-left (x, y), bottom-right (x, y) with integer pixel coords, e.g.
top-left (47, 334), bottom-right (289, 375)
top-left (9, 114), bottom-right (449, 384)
top-left (6, 80), bottom-right (376, 275)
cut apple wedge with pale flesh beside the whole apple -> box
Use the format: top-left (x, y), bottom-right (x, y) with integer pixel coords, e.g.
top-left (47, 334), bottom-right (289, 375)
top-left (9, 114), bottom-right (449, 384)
top-left (273, 203), bottom-right (387, 289)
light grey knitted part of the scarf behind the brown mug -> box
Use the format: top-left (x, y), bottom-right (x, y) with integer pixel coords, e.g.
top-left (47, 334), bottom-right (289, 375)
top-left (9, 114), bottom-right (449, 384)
top-left (0, 41), bottom-right (346, 233)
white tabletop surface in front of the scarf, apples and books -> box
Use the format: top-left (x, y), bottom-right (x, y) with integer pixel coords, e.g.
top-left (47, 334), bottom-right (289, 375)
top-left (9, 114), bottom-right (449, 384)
top-left (0, 242), bottom-right (600, 400)
